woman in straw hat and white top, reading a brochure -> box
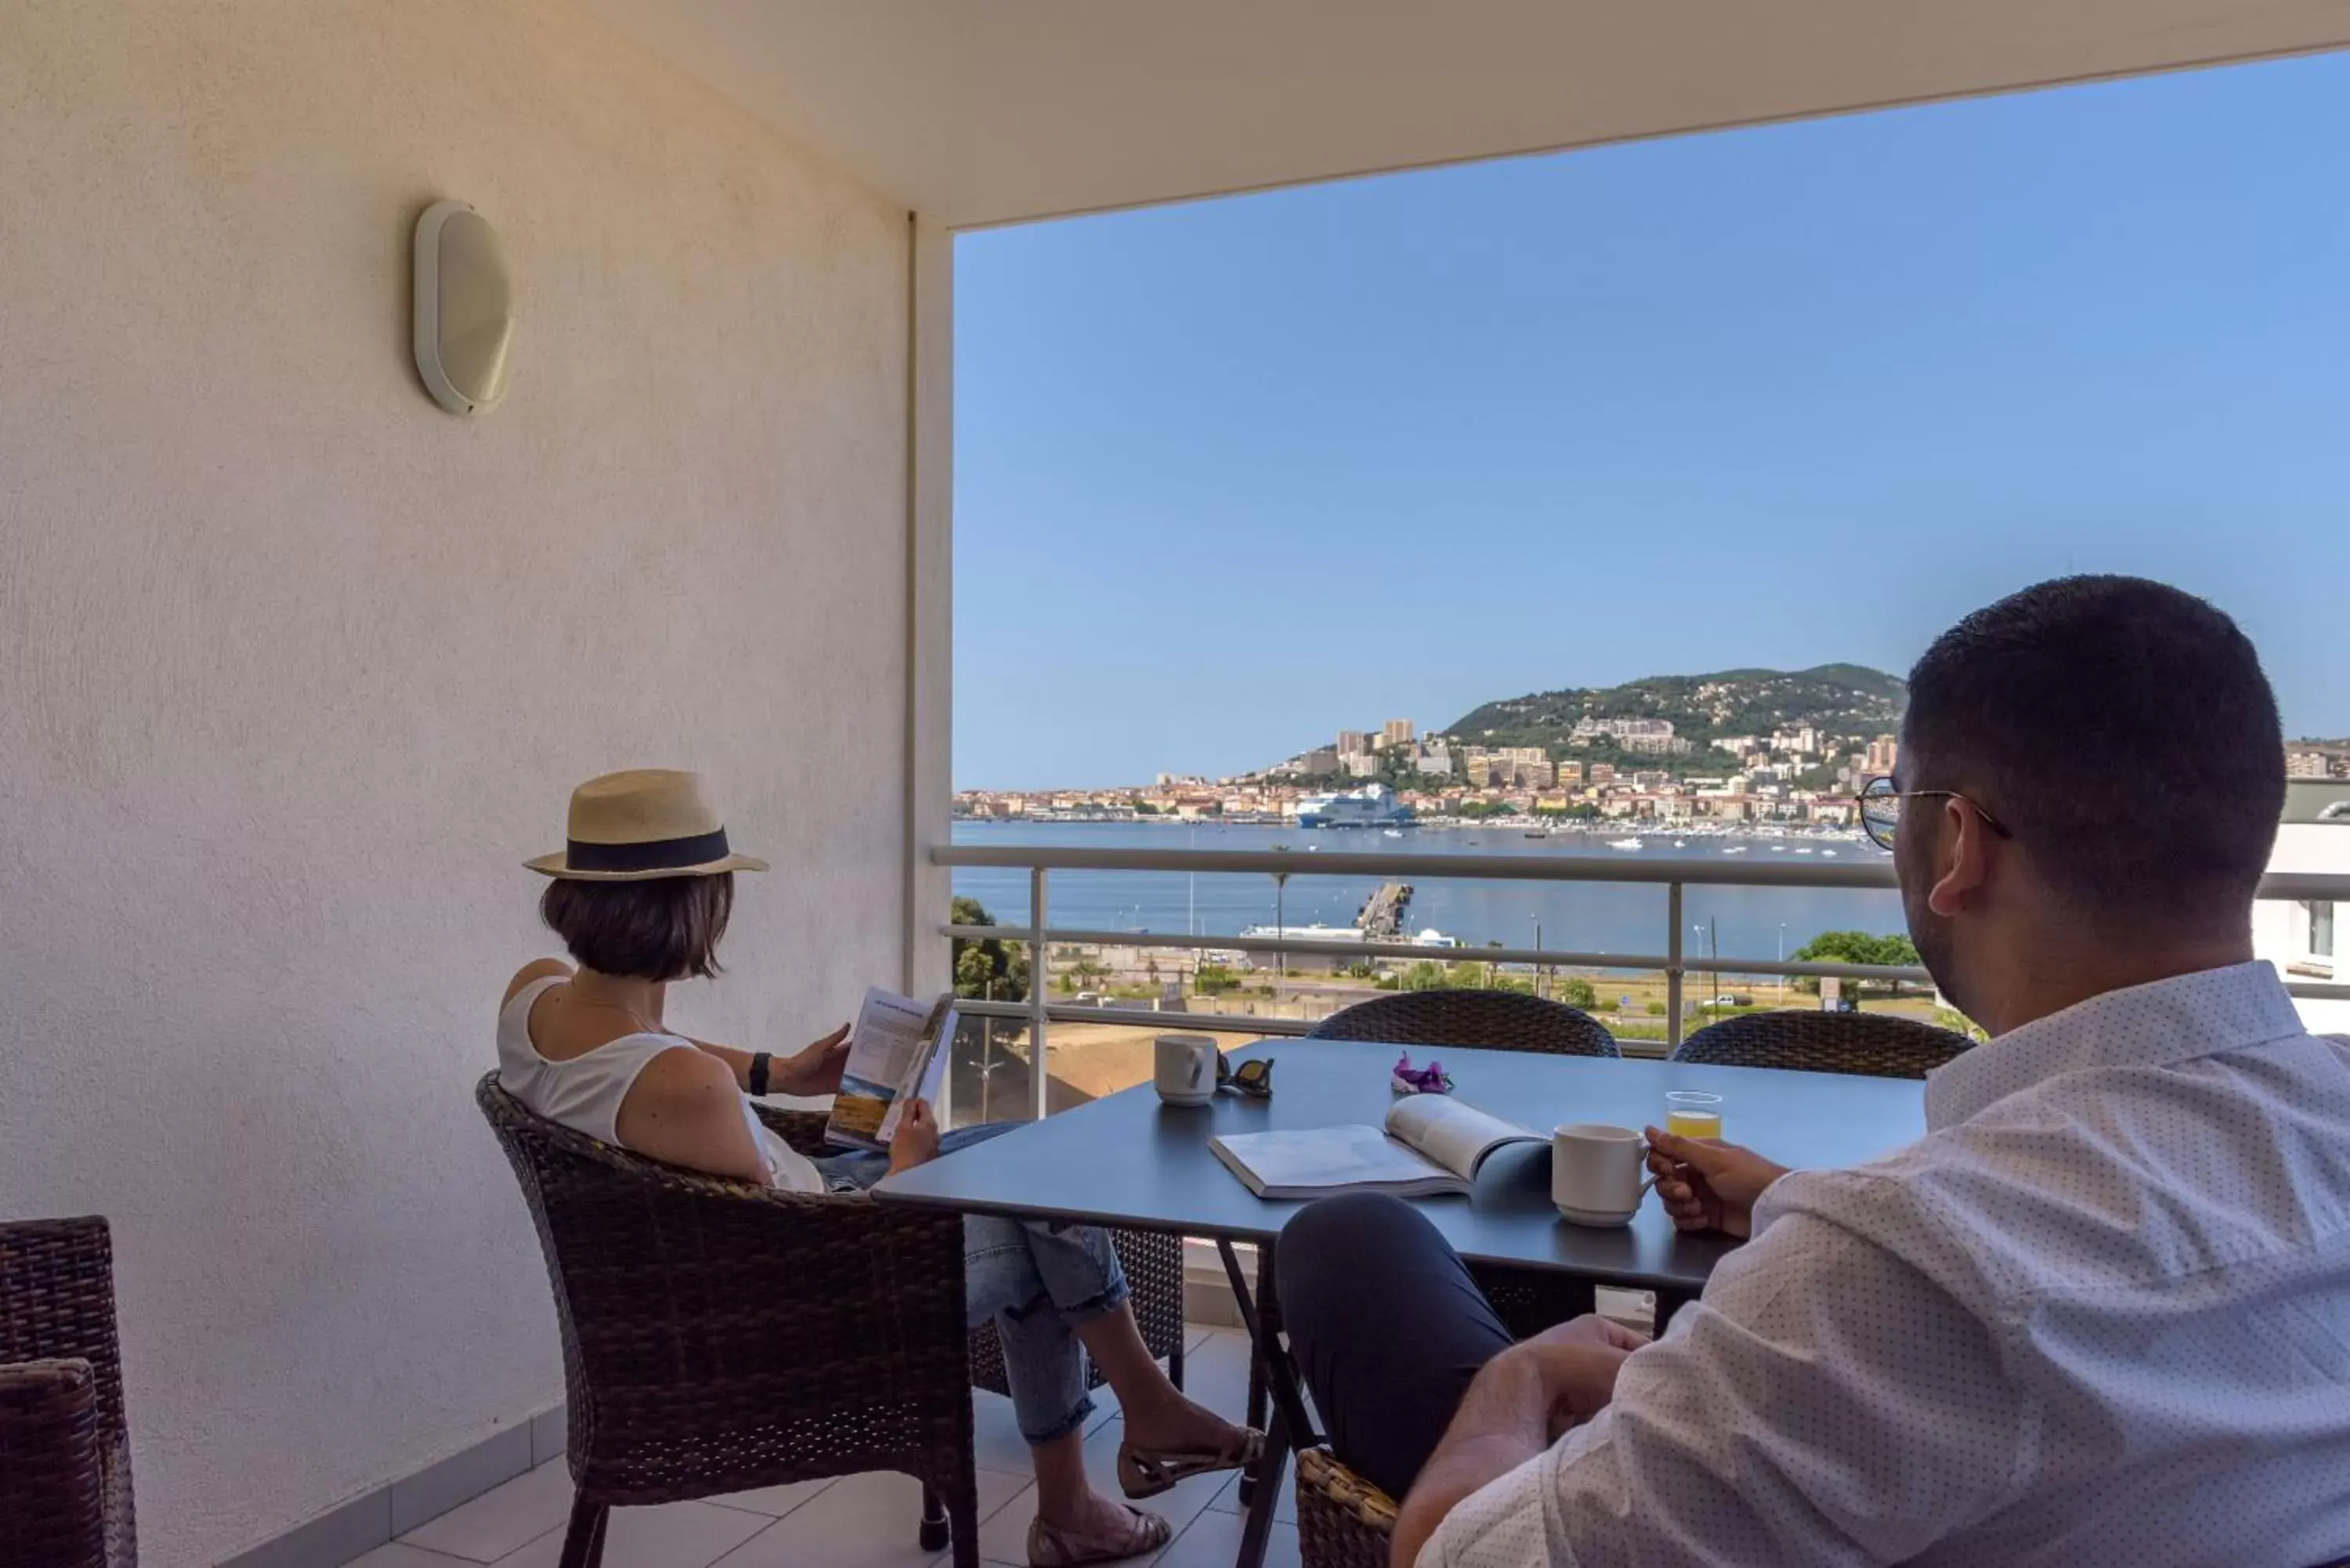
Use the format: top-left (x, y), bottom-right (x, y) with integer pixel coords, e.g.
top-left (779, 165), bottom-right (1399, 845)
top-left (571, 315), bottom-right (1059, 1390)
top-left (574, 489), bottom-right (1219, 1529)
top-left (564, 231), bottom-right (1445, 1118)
top-left (498, 768), bottom-right (1260, 1568)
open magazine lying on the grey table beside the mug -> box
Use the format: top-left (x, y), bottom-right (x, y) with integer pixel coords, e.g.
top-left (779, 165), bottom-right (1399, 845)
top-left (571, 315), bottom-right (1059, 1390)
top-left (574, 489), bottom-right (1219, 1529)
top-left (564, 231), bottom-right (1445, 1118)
top-left (1208, 1096), bottom-right (1544, 1199)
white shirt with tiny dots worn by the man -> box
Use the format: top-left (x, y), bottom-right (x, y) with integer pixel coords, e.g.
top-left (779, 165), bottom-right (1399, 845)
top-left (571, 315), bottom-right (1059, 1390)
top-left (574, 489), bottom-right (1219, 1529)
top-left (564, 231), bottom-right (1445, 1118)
top-left (1419, 964), bottom-right (2350, 1568)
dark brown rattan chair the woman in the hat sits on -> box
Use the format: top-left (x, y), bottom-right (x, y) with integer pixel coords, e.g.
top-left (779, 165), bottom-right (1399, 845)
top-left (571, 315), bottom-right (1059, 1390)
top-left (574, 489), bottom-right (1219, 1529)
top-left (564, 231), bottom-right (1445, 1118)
top-left (475, 1072), bottom-right (980, 1568)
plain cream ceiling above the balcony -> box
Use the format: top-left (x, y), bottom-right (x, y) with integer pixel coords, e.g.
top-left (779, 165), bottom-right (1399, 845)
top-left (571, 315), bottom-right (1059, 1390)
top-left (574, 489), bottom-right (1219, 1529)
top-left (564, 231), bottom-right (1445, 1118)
top-left (588, 0), bottom-right (2350, 226)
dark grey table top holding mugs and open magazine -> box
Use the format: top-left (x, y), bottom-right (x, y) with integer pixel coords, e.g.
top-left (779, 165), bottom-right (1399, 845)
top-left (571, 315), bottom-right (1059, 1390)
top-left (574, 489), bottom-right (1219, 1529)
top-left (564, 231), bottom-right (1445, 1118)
top-left (874, 1039), bottom-right (1925, 1291)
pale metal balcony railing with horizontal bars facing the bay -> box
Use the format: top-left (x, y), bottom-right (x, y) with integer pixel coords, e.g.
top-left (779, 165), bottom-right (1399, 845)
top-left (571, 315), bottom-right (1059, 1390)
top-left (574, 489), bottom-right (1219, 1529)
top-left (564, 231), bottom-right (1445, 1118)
top-left (931, 844), bottom-right (2350, 1117)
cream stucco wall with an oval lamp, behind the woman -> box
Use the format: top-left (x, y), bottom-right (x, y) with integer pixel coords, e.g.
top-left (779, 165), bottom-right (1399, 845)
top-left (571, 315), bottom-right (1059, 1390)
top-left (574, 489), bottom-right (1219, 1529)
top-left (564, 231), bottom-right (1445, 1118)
top-left (0, 0), bottom-right (909, 1568)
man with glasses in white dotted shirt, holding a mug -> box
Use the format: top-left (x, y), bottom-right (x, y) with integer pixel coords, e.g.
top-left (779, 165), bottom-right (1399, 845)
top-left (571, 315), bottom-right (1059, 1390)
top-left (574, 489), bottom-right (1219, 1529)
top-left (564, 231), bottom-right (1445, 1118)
top-left (1278, 578), bottom-right (2350, 1568)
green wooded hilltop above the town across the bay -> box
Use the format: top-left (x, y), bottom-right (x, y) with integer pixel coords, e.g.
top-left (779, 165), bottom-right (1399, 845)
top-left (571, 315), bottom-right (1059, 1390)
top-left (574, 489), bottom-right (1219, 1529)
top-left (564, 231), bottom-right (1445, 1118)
top-left (1443, 665), bottom-right (1908, 745)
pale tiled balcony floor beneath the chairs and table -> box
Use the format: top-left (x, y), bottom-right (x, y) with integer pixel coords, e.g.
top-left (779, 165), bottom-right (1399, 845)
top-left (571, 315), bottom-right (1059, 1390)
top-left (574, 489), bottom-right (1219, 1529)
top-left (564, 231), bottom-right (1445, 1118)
top-left (348, 1328), bottom-right (1297, 1568)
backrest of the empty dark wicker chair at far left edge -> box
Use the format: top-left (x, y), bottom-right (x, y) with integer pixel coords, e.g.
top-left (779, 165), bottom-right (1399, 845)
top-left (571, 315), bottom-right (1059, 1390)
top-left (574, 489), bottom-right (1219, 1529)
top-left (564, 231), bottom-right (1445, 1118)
top-left (0, 1216), bottom-right (136, 1568)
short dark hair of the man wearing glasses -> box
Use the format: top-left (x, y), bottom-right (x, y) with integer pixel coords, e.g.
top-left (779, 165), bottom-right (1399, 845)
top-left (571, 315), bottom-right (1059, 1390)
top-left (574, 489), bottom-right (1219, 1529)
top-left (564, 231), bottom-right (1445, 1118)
top-left (1901, 576), bottom-right (2284, 924)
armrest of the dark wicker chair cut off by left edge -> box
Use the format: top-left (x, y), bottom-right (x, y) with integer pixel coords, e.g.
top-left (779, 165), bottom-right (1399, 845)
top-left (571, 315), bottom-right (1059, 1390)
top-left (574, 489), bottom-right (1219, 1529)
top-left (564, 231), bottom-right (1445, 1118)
top-left (0, 1361), bottom-right (106, 1568)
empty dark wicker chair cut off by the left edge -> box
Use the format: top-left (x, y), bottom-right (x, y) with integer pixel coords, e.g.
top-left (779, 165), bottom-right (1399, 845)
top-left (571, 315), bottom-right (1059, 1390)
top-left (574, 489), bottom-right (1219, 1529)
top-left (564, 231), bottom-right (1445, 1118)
top-left (0, 1218), bottom-right (139, 1568)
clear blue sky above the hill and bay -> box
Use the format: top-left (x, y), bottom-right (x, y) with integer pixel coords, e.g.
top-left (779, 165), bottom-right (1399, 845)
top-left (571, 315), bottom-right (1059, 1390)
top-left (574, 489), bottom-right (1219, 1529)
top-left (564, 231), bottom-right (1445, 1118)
top-left (954, 56), bottom-right (2350, 788)
